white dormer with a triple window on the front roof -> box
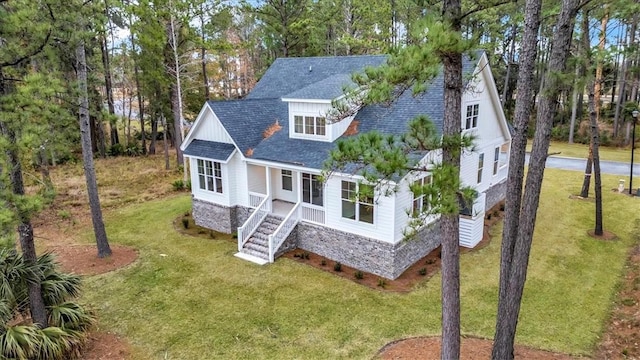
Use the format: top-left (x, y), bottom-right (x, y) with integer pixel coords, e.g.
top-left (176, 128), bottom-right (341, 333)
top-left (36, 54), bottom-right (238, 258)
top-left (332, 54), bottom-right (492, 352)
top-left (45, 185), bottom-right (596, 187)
top-left (282, 74), bottom-right (354, 142)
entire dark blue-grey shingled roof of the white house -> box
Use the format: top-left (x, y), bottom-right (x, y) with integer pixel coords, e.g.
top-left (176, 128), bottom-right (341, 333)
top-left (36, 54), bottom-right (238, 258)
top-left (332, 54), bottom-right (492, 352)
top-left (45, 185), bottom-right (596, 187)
top-left (198, 52), bottom-right (481, 169)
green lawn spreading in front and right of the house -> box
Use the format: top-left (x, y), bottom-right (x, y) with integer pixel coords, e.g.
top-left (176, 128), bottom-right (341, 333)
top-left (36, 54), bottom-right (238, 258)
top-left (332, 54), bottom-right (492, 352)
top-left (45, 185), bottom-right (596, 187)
top-left (84, 169), bottom-right (640, 359)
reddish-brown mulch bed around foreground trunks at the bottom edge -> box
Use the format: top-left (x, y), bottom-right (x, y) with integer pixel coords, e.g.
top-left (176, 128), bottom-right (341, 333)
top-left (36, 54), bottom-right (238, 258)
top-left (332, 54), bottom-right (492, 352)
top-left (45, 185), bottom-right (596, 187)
top-left (375, 337), bottom-right (582, 360)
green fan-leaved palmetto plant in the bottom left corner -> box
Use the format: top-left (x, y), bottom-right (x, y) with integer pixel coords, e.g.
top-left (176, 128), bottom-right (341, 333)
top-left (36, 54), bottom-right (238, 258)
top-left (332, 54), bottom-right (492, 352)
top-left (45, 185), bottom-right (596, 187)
top-left (0, 249), bottom-right (94, 359)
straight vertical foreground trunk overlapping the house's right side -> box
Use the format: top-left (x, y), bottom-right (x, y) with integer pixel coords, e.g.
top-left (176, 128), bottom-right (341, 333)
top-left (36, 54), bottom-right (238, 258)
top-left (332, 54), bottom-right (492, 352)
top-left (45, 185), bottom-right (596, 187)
top-left (440, 0), bottom-right (462, 360)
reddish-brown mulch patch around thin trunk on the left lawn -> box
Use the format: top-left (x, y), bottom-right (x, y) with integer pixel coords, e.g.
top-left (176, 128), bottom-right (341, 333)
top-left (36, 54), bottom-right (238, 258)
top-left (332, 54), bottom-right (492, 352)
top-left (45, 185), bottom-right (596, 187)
top-left (49, 245), bottom-right (138, 275)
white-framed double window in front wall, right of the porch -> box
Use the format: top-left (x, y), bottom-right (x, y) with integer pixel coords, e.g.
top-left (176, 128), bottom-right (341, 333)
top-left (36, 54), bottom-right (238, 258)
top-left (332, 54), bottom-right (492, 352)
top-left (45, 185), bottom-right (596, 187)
top-left (341, 180), bottom-right (375, 224)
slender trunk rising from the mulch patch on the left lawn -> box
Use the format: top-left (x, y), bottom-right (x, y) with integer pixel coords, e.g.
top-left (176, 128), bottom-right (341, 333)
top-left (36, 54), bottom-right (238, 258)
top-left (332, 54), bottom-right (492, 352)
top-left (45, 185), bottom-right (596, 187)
top-left (76, 42), bottom-right (111, 258)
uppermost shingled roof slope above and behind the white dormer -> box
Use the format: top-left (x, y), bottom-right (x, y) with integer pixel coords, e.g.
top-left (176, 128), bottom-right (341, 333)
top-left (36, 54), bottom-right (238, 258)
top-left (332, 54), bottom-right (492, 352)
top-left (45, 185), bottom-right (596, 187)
top-left (247, 55), bottom-right (387, 99)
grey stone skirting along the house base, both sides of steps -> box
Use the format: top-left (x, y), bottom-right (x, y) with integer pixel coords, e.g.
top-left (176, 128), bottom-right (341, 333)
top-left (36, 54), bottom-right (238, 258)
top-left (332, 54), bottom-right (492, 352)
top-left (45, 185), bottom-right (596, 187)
top-left (192, 198), bottom-right (441, 280)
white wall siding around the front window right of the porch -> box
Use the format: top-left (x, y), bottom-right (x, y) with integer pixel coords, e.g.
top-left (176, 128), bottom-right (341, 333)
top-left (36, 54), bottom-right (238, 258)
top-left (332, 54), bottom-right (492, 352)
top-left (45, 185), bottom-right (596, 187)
top-left (324, 175), bottom-right (395, 243)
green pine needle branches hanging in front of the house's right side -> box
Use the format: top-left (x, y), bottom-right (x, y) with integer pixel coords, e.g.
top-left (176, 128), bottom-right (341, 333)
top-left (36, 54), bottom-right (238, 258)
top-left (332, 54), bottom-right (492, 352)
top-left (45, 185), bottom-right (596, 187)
top-left (324, 16), bottom-right (477, 238)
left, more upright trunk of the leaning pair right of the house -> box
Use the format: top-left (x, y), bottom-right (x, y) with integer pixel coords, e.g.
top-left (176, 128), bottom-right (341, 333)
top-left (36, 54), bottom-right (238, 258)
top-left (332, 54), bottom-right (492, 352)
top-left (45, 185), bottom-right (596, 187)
top-left (492, 0), bottom-right (542, 360)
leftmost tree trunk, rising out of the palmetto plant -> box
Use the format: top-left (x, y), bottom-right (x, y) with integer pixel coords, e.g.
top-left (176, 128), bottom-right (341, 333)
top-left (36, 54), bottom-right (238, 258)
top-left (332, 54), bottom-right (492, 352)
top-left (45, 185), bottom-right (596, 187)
top-left (0, 119), bottom-right (48, 328)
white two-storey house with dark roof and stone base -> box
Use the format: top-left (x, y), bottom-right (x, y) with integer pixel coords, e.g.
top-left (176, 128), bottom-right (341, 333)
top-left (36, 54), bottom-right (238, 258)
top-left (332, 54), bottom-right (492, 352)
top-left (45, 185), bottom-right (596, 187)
top-left (182, 52), bottom-right (511, 279)
